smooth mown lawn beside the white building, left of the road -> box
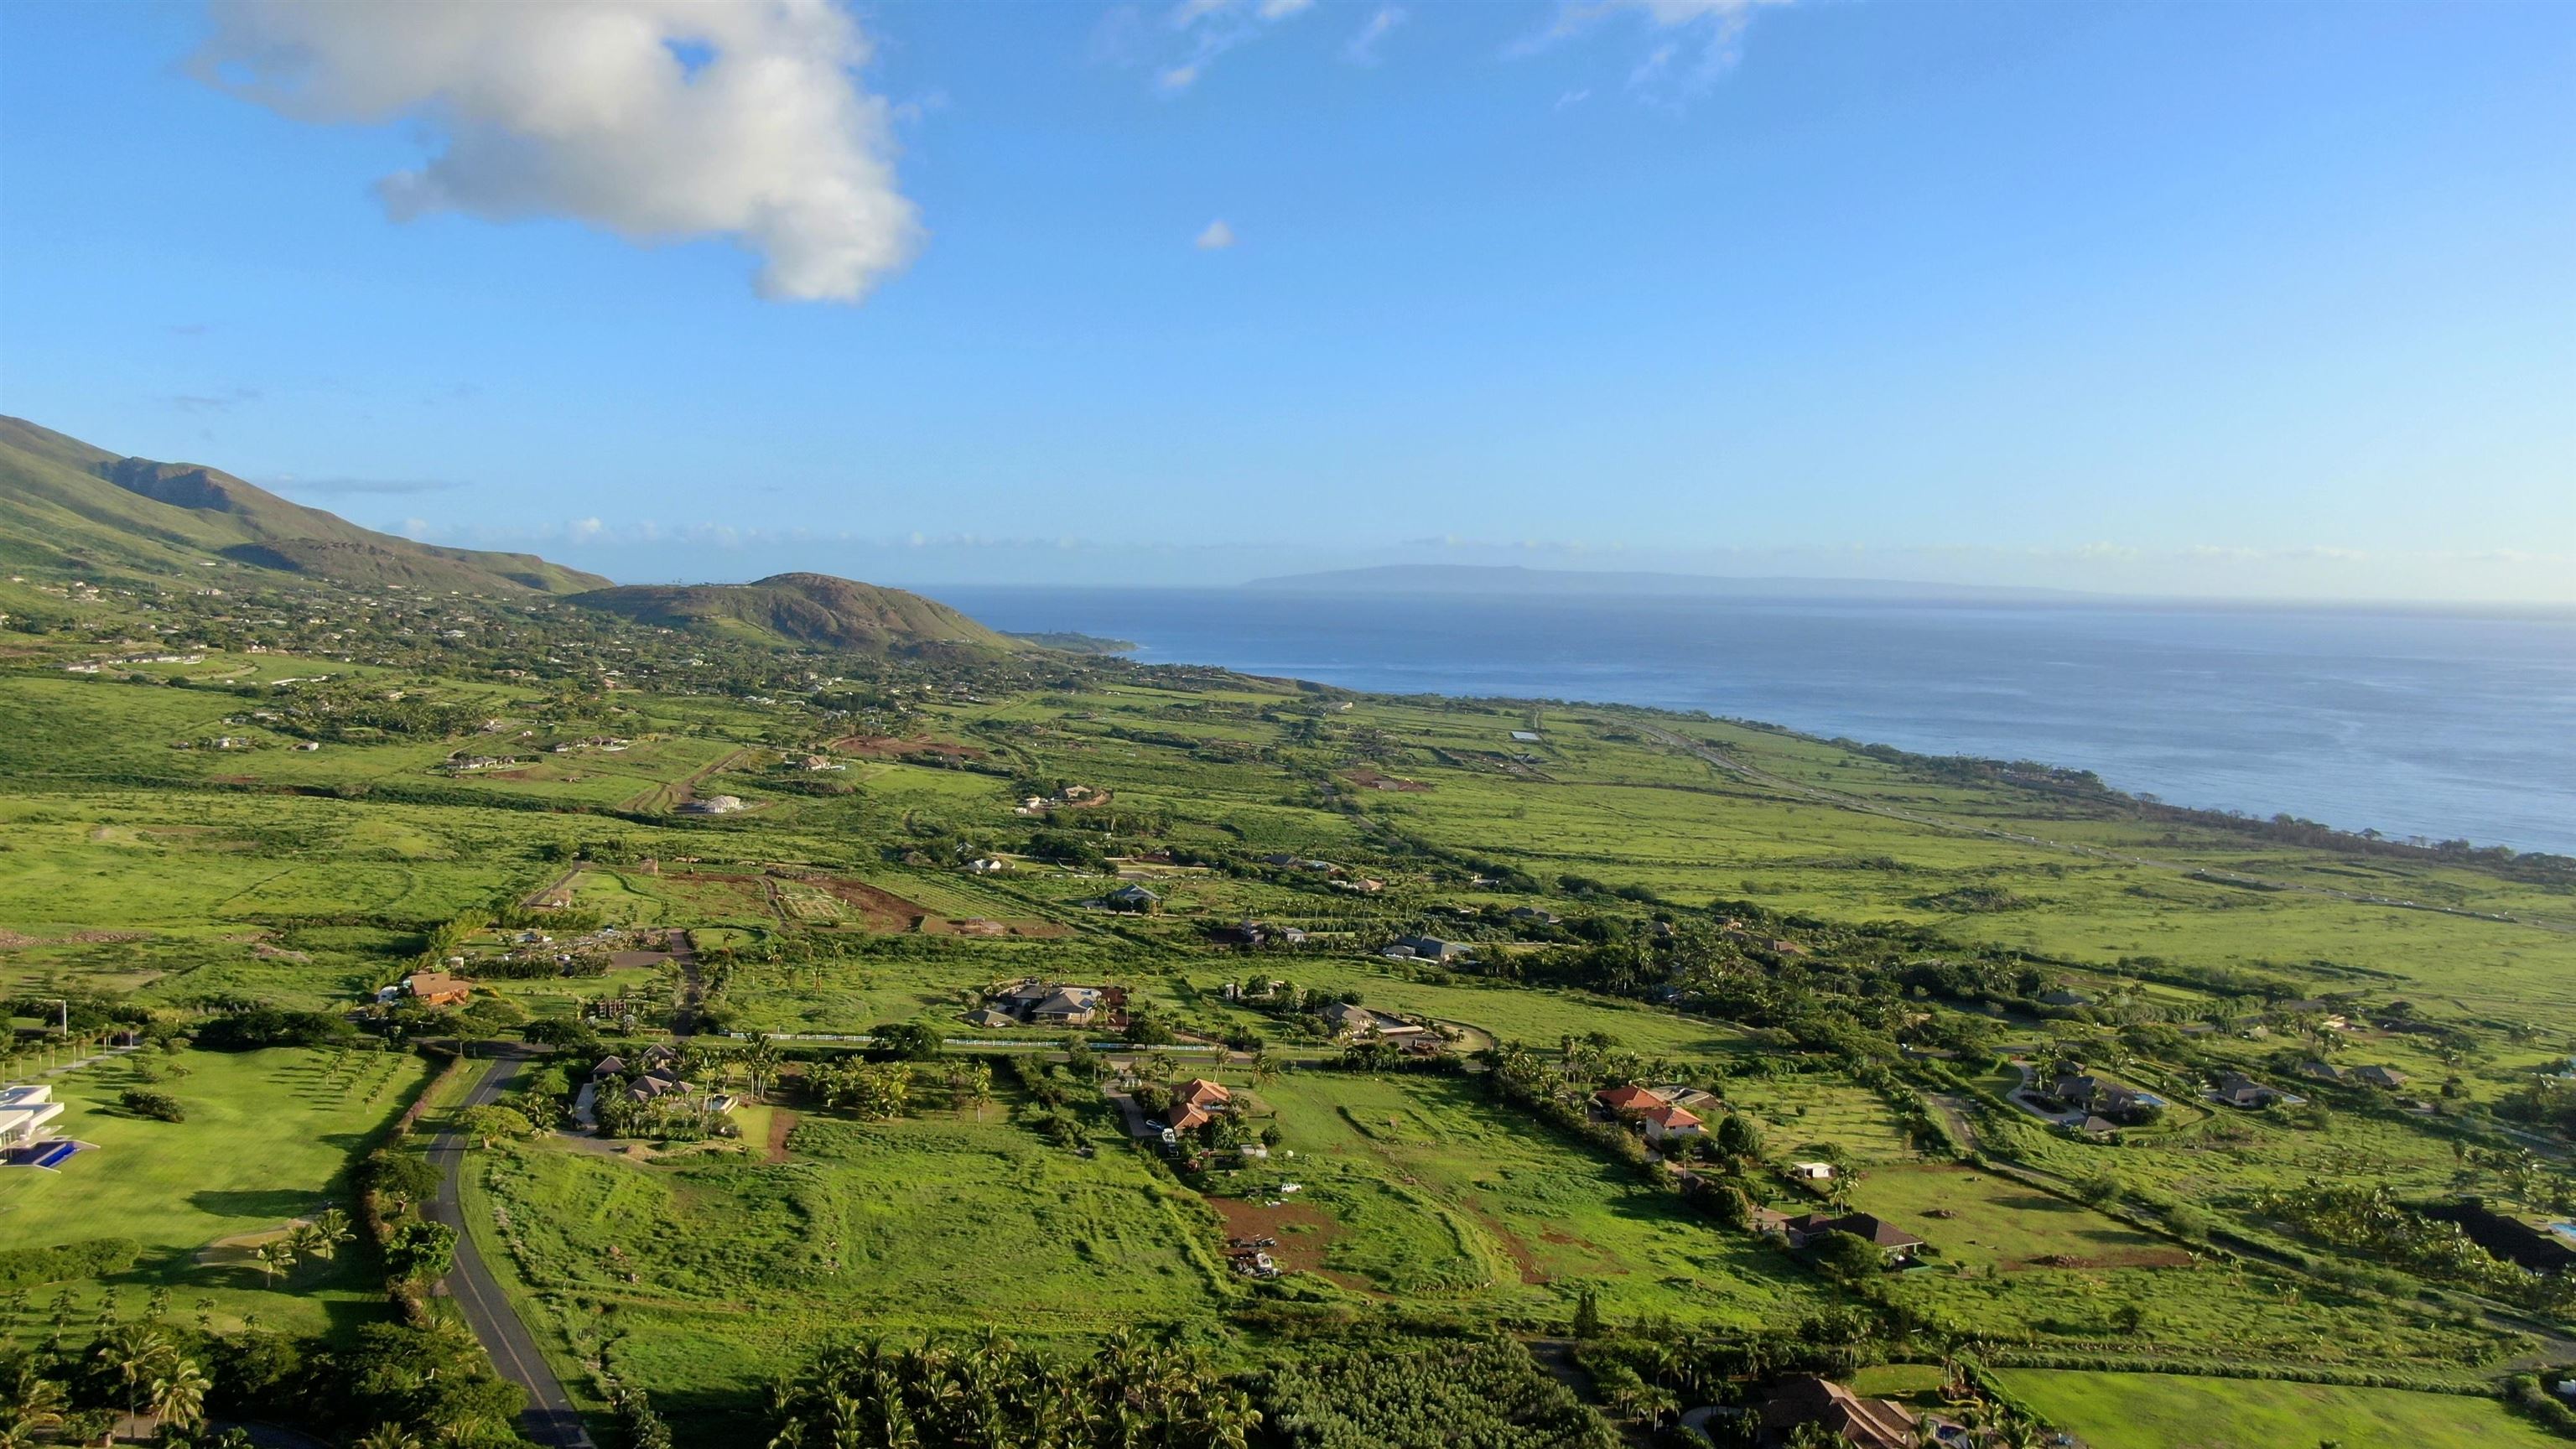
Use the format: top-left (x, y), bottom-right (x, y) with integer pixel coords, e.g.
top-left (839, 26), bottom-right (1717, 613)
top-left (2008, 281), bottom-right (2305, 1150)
top-left (0, 1049), bottom-right (430, 1333)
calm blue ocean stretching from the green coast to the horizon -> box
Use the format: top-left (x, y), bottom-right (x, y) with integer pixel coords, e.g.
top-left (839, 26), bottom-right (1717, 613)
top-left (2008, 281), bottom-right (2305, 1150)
top-left (927, 588), bottom-right (2576, 854)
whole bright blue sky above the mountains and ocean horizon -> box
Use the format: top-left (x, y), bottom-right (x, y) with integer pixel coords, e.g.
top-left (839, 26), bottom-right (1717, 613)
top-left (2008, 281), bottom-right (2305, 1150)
top-left (0, 0), bottom-right (2576, 600)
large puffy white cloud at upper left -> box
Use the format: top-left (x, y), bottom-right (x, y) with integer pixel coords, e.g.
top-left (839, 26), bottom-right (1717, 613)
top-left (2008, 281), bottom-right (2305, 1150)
top-left (193, 0), bottom-right (920, 302)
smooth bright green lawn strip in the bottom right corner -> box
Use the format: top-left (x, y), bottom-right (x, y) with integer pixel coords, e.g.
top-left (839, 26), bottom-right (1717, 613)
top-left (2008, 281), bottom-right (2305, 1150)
top-left (1997, 1369), bottom-right (2566, 1449)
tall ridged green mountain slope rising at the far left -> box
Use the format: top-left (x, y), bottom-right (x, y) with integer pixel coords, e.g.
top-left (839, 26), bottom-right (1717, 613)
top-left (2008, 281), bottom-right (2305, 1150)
top-left (0, 418), bottom-right (608, 593)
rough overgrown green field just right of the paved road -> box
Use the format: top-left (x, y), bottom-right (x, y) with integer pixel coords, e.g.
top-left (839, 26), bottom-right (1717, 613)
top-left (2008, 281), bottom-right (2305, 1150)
top-left (479, 1106), bottom-right (1228, 1444)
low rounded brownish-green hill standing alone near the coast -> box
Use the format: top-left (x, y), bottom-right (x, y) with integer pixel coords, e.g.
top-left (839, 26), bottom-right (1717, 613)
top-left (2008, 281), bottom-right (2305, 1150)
top-left (572, 573), bottom-right (1023, 655)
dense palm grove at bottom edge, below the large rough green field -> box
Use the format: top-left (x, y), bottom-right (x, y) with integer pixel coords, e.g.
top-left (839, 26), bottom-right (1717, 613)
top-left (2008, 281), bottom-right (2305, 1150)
top-left (771, 1327), bottom-right (1262, 1449)
